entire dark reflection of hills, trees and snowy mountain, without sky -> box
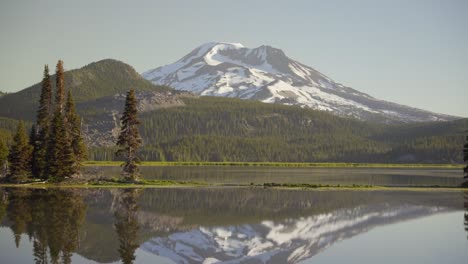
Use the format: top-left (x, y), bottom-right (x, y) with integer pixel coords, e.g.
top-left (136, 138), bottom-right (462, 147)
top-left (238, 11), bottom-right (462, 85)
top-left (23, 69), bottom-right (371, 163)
top-left (0, 188), bottom-right (468, 263)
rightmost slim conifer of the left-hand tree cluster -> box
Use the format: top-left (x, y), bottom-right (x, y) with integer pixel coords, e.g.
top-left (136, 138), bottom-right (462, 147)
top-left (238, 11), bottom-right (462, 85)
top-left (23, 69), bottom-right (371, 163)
top-left (65, 90), bottom-right (87, 174)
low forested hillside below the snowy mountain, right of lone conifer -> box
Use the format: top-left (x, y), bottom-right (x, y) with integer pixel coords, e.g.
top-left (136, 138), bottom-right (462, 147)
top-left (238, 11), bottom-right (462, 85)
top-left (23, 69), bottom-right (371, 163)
top-left (86, 97), bottom-right (468, 163)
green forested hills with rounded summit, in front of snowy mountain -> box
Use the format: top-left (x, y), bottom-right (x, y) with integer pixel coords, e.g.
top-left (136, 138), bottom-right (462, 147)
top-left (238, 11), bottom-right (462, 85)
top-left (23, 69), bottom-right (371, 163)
top-left (0, 60), bottom-right (462, 163)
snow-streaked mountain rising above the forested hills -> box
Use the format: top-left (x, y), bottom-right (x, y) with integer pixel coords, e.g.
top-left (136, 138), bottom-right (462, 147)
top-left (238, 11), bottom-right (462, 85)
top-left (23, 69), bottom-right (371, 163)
top-left (142, 42), bottom-right (457, 122)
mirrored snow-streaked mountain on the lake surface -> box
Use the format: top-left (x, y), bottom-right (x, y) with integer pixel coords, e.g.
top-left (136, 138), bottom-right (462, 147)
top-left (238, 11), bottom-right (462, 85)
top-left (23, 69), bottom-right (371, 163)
top-left (141, 205), bottom-right (450, 264)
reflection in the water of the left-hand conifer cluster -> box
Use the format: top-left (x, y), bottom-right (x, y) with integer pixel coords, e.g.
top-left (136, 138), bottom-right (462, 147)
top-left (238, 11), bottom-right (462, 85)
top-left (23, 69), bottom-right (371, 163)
top-left (0, 188), bottom-right (86, 264)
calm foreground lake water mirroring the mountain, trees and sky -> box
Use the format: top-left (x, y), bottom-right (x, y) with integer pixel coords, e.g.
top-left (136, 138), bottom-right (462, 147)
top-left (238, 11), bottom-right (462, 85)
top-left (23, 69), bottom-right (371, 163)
top-left (0, 184), bottom-right (468, 263)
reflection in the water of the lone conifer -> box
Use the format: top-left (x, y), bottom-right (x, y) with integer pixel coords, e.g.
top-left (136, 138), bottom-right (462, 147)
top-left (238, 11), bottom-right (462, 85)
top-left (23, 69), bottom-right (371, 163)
top-left (114, 189), bottom-right (141, 264)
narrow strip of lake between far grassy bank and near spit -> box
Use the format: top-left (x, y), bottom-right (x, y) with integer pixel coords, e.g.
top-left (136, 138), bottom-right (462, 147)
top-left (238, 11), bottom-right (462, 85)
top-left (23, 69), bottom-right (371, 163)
top-left (86, 166), bottom-right (463, 186)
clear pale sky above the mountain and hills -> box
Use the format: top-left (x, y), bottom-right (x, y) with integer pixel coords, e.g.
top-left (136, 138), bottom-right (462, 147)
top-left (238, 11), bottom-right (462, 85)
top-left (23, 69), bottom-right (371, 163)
top-left (0, 0), bottom-right (468, 117)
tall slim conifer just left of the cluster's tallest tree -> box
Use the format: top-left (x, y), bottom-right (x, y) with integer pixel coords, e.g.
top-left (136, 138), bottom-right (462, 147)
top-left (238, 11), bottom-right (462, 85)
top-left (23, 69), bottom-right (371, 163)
top-left (32, 65), bottom-right (52, 178)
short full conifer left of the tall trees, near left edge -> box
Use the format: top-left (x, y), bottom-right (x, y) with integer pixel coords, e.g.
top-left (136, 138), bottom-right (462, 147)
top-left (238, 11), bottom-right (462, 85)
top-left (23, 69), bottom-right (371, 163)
top-left (7, 121), bottom-right (32, 183)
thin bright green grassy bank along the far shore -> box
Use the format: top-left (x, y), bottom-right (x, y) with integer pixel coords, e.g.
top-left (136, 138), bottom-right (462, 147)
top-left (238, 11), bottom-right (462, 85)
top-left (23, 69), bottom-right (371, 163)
top-left (84, 161), bottom-right (463, 169)
